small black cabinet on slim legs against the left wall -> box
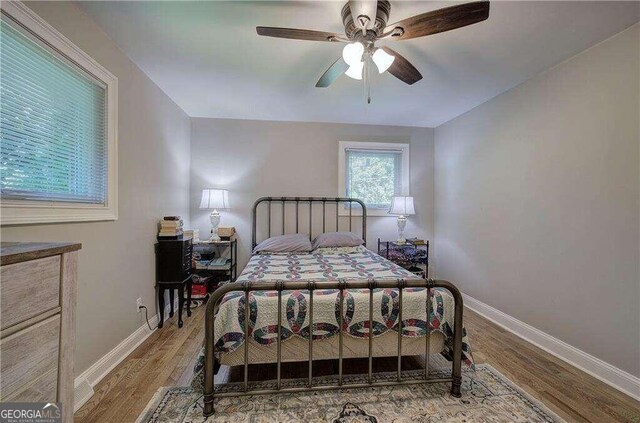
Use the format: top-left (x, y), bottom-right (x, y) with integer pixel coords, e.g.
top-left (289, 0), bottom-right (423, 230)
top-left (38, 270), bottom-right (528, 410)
top-left (156, 238), bottom-right (193, 328)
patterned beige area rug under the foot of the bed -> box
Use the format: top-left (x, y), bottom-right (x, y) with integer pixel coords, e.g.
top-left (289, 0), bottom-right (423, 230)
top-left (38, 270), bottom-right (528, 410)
top-left (137, 364), bottom-right (563, 423)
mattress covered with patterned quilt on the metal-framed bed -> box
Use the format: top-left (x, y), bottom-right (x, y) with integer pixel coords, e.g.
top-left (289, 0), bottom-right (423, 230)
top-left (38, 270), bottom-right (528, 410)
top-left (214, 247), bottom-right (473, 366)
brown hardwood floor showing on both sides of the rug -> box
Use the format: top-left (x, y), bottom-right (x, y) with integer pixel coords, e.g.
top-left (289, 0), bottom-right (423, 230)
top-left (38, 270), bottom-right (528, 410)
top-left (75, 307), bottom-right (640, 423)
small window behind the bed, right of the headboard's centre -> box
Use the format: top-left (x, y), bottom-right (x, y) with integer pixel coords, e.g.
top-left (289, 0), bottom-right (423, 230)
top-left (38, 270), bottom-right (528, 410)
top-left (338, 141), bottom-right (409, 216)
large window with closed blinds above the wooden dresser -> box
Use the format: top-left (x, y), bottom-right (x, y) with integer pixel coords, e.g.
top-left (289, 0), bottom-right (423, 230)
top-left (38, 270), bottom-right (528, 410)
top-left (0, 3), bottom-right (116, 224)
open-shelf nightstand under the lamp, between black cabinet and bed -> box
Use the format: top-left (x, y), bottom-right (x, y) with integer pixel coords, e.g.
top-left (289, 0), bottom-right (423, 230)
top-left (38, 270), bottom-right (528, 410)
top-left (191, 238), bottom-right (238, 300)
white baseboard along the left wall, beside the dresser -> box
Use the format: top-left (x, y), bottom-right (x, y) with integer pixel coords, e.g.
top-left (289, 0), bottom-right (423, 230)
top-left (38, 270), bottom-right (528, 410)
top-left (73, 303), bottom-right (177, 413)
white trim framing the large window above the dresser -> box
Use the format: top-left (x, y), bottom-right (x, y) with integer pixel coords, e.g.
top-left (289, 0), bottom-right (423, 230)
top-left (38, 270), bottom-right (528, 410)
top-left (0, 1), bottom-right (118, 225)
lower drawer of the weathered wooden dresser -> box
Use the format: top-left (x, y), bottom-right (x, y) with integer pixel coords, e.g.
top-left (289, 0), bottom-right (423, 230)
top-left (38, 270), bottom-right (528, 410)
top-left (0, 314), bottom-right (60, 401)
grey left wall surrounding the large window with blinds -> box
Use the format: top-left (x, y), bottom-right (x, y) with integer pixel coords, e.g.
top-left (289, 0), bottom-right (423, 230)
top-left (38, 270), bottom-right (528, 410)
top-left (1, 2), bottom-right (190, 375)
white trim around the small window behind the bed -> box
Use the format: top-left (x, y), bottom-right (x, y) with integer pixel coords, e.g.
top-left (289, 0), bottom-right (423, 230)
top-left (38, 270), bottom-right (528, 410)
top-left (338, 141), bottom-right (411, 216)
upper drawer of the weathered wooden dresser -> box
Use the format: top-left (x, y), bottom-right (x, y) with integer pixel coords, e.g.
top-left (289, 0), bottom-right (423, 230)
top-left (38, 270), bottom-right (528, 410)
top-left (0, 256), bottom-right (60, 330)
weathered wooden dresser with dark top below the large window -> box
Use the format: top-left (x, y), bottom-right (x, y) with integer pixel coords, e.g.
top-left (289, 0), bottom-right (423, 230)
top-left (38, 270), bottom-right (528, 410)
top-left (0, 242), bottom-right (81, 423)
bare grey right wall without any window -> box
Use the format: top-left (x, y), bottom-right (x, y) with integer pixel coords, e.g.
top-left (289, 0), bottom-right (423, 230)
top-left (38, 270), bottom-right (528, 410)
top-left (435, 25), bottom-right (640, 376)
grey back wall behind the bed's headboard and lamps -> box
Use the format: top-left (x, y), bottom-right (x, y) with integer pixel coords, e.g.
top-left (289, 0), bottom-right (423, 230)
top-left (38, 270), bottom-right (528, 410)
top-left (191, 118), bottom-right (433, 268)
